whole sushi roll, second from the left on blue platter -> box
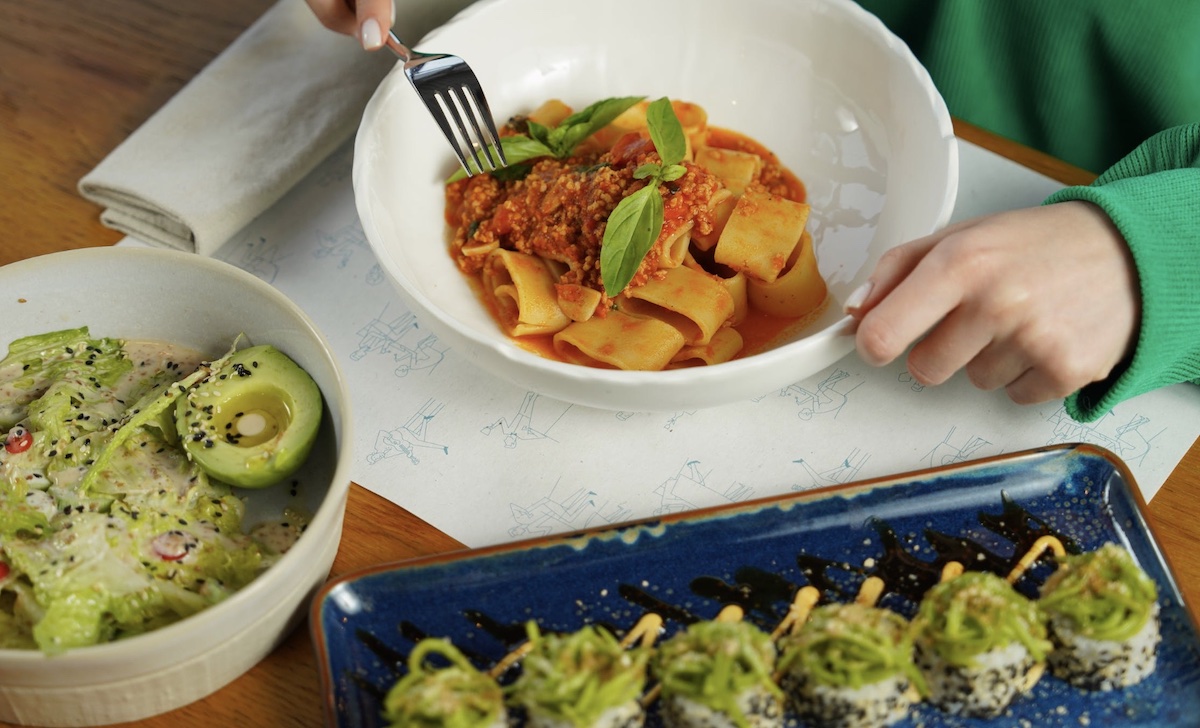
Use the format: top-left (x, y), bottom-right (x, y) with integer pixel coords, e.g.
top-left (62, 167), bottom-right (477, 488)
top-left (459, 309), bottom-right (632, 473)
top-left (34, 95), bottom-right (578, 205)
top-left (509, 622), bottom-right (650, 728)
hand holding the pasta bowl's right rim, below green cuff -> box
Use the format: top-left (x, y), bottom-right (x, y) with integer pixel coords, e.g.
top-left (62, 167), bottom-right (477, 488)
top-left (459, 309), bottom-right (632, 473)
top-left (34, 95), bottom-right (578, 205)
top-left (846, 201), bottom-right (1141, 404)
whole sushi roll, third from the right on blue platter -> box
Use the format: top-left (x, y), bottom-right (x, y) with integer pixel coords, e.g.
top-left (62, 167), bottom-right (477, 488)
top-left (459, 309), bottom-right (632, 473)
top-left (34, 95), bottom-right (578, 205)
top-left (779, 603), bottom-right (924, 728)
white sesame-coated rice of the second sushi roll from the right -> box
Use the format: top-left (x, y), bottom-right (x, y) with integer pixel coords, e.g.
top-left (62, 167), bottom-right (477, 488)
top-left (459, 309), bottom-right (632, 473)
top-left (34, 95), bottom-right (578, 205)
top-left (914, 642), bottom-right (1043, 718)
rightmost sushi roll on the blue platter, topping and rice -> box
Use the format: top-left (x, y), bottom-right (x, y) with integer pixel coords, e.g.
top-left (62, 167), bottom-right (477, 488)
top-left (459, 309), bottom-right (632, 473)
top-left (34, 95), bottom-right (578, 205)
top-left (1039, 543), bottom-right (1160, 690)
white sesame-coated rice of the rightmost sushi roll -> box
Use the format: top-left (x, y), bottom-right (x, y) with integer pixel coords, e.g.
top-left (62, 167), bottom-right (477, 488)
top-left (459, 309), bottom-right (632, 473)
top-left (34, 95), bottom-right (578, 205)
top-left (1046, 604), bottom-right (1162, 691)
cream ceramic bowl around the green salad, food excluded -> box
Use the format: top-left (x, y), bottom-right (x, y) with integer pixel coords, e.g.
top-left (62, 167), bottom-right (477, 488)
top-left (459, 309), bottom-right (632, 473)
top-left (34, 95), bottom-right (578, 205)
top-left (0, 247), bottom-right (353, 726)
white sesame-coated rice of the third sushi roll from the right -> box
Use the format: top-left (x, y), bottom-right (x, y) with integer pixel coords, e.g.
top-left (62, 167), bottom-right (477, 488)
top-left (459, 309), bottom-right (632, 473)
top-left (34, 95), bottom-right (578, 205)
top-left (781, 670), bottom-right (917, 728)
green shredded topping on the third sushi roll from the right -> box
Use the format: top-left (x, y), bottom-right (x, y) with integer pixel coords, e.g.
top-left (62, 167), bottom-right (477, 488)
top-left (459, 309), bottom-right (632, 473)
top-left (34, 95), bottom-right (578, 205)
top-left (780, 603), bottom-right (928, 694)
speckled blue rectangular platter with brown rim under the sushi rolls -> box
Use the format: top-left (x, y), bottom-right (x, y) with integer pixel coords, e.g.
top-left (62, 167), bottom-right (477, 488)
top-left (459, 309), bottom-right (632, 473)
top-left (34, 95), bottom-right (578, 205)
top-left (311, 445), bottom-right (1200, 727)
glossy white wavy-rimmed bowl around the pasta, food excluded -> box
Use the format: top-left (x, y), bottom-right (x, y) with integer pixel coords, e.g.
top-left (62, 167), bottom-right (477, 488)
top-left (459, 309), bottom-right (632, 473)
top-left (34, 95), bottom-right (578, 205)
top-left (354, 0), bottom-right (958, 411)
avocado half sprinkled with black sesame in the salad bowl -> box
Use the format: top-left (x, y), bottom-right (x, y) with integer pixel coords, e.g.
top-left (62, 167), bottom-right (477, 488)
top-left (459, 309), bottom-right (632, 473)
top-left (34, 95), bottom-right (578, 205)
top-left (175, 344), bottom-right (323, 488)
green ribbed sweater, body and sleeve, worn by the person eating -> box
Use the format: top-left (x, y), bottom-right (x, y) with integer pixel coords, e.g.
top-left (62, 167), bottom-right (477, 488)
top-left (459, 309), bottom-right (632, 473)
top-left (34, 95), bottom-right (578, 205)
top-left (859, 0), bottom-right (1200, 421)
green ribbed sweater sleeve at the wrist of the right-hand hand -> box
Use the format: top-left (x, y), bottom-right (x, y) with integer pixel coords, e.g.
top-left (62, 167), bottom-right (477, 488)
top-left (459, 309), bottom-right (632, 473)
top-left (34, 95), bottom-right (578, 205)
top-left (1045, 124), bottom-right (1200, 422)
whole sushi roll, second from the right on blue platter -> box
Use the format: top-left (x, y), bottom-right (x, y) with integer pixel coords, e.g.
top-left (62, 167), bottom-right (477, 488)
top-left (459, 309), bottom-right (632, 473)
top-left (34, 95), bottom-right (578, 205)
top-left (912, 571), bottom-right (1052, 718)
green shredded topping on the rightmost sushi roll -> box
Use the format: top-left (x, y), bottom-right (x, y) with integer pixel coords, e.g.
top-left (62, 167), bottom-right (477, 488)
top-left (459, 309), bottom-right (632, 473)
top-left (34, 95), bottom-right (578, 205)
top-left (1039, 543), bottom-right (1158, 642)
